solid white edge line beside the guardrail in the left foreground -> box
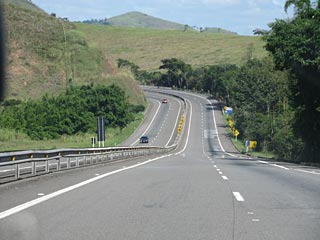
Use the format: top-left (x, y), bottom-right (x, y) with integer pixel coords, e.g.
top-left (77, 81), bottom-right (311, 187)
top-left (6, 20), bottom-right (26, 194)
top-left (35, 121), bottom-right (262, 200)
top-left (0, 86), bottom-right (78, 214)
top-left (0, 154), bottom-right (173, 219)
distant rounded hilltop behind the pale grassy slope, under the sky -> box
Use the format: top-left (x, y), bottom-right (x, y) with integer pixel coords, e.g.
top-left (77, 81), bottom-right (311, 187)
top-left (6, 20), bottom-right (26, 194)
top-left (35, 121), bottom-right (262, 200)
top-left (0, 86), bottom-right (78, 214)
top-left (108, 12), bottom-right (189, 30)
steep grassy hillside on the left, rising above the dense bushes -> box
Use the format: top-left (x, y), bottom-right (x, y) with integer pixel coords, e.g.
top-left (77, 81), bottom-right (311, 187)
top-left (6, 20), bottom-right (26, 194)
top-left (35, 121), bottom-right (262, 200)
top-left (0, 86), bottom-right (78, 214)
top-left (4, 0), bottom-right (144, 104)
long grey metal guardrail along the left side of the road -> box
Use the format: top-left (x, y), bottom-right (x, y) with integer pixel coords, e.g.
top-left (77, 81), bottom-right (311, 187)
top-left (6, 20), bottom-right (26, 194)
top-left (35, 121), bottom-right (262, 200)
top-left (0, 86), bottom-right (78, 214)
top-left (0, 145), bottom-right (176, 182)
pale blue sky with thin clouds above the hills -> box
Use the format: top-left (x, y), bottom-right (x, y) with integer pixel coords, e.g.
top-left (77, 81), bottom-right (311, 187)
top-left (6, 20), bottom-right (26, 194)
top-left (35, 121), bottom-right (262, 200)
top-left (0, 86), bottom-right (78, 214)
top-left (32, 0), bottom-right (290, 35)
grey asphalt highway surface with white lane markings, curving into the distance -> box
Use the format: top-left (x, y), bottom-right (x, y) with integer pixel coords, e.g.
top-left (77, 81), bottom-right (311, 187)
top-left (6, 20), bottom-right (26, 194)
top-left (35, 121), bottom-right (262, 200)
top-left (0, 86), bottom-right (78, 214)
top-left (0, 91), bottom-right (320, 240)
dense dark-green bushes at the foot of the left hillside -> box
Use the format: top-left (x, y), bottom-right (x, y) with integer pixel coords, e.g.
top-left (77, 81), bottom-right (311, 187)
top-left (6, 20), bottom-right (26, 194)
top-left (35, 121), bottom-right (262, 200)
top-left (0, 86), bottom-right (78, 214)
top-left (0, 85), bottom-right (144, 140)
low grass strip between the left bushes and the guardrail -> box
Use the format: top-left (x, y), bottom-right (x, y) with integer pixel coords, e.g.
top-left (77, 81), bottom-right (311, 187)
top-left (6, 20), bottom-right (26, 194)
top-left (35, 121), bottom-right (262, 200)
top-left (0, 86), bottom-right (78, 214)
top-left (0, 113), bottom-right (143, 152)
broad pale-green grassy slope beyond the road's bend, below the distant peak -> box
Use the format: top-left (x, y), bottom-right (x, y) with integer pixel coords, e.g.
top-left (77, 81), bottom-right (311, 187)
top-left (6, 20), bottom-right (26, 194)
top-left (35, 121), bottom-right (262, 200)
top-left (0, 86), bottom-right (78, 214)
top-left (76, 23), bottom-right (267, 71)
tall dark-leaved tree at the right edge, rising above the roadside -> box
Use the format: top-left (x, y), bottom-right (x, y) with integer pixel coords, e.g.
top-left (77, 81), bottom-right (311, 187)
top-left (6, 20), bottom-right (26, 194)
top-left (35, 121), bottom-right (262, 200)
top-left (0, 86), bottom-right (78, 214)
top-left (264, 0), bottom-right (320, 162)
